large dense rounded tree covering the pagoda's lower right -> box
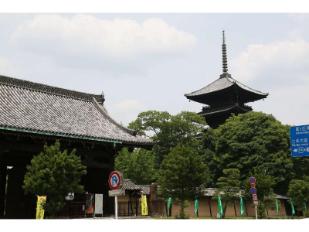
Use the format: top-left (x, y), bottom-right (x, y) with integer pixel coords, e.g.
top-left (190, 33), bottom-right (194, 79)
top-left (206, 112), bottom-right (294, 194)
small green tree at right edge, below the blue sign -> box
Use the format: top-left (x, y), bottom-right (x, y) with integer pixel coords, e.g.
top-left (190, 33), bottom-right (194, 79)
top-left (288, 178), bottom-right (309, 215)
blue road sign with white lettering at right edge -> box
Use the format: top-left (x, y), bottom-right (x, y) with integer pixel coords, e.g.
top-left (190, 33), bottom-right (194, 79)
top-left (290, 125), bottom-right (309, 157)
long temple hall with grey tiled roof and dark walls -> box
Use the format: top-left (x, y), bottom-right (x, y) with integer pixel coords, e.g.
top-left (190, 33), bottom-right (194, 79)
top-left (0, 76), bottom-right (152, 218)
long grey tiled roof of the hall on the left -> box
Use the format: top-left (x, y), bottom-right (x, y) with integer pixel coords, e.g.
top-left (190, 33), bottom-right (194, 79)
top-left (0, 76), bottom-right (152, 145)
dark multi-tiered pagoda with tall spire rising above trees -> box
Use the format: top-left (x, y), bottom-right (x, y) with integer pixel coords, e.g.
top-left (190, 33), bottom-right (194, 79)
top-left (185, 31), bottom-right (268, 128)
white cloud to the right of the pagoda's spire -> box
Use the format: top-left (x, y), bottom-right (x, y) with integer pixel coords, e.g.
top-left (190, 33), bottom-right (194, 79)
top-left (232, 39), bottom-right (309, 85)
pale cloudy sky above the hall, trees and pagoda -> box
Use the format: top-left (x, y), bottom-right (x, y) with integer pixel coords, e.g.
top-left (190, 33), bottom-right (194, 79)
top-left (0, 13), bottom-right (309, 125)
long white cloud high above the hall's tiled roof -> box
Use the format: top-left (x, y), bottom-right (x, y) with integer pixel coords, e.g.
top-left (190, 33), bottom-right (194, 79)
top-left (11, 15), bottom-right (196, 61)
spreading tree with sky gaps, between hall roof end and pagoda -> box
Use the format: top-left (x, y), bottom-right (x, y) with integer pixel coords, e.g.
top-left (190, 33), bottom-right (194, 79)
top-left (128, 111), bottom-right (206, 167)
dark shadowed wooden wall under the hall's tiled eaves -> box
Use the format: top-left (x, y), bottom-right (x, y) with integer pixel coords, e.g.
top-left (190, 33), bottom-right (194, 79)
top-left (0, 131), bottom-right (122, 218)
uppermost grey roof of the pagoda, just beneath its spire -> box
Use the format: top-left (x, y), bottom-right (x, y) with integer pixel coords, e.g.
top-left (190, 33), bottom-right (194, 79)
top-left (185, 73), bottom-right (268, 104)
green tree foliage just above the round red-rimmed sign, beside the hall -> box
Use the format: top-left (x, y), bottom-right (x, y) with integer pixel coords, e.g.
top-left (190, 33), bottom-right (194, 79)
top-left (115, 148), bottom-right (156, 184)
